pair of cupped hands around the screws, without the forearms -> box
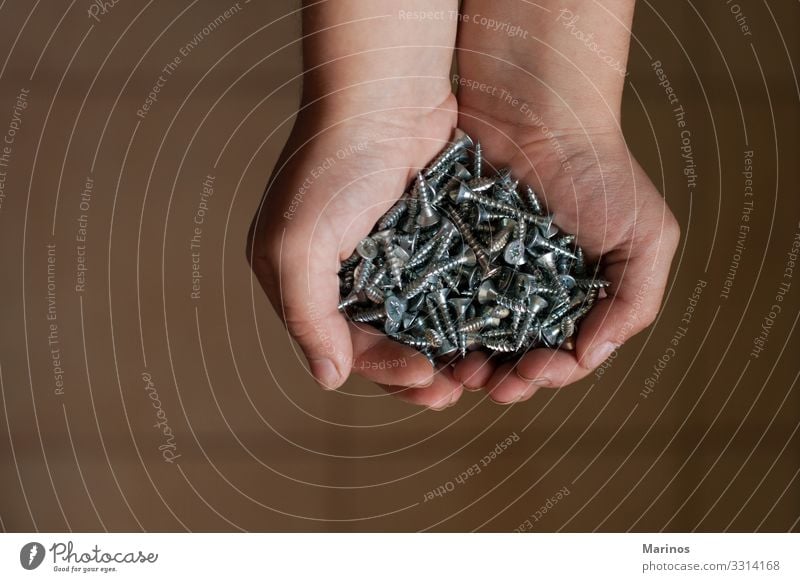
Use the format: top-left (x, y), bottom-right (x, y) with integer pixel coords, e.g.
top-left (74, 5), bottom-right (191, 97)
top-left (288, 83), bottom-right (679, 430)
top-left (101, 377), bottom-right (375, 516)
top-left (248, 45), bottom-right (679, 410)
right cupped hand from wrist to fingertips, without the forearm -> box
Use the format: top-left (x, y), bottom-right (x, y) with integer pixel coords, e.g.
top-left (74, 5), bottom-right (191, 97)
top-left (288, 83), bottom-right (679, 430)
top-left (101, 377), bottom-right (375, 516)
top-left (456, 107), bottom-right (678, 402)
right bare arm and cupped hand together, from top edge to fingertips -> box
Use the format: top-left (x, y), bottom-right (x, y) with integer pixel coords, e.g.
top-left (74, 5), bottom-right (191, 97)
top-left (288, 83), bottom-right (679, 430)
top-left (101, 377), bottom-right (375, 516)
top-left (455, 0), bottom-right (679, 403)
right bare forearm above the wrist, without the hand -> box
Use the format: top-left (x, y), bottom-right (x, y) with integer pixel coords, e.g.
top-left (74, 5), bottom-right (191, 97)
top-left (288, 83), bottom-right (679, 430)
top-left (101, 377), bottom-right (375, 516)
top-left (458, 0), bottom-right (635, 127)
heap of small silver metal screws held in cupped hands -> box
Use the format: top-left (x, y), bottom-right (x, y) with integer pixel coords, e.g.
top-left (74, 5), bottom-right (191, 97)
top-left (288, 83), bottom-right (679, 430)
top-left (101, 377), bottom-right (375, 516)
top-left (339, 129), bottom-right (609, 360)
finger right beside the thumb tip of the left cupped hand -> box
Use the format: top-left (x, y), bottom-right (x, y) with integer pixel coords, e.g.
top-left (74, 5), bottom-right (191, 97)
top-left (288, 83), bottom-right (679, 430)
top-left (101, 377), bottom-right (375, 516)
top-left (350, 324), bottom-right (434, 387)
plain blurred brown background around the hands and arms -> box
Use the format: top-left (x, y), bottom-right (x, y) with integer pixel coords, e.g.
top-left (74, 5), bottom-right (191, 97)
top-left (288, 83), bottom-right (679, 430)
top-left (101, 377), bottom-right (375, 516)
top-left (0, 0), bottom-right (800, 531)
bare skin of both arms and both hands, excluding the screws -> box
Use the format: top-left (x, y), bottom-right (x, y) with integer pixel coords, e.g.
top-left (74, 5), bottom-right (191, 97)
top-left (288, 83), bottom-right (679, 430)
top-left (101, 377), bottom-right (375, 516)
top-left (248, 0), bottom-right (679, 410)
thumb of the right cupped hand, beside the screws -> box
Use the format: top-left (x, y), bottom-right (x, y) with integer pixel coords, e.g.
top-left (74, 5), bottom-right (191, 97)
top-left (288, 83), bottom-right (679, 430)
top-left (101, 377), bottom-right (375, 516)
top-left (576, 215), bottom-right (679, 371)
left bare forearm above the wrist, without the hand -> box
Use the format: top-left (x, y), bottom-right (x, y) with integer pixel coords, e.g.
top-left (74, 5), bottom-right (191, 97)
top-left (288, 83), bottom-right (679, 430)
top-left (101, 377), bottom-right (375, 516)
top-left (303, 0), bottom-right (458, 111)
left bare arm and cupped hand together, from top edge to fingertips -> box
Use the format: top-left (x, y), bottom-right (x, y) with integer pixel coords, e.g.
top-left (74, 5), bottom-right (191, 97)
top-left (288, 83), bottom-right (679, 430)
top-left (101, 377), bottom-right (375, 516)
top-left (248, 0), bottom-right (468, 409)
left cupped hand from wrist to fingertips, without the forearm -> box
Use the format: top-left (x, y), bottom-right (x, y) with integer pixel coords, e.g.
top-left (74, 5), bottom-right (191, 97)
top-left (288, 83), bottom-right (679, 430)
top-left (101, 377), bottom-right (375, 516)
top-left (249, 73), bottom-right (461, 409)
